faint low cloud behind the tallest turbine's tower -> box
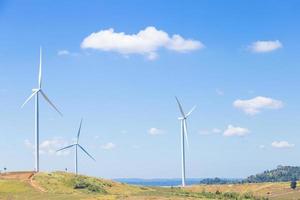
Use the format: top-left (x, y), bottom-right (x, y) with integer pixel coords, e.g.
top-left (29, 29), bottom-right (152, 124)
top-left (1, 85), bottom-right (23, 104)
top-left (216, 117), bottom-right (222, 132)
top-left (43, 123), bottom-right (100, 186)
top-left (24, 138), bottom-right (70, 156)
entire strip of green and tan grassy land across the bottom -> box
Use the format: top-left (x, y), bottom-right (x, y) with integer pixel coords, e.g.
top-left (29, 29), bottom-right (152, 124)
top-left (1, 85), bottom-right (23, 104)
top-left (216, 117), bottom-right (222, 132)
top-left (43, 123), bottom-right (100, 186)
top-left (0, 172), bottom-right (300, 200)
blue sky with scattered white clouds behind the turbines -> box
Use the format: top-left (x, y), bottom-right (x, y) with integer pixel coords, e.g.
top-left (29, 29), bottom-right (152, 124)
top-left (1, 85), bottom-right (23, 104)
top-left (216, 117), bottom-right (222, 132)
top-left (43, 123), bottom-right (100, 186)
top-left (0, 0), bottom-right (300, 178)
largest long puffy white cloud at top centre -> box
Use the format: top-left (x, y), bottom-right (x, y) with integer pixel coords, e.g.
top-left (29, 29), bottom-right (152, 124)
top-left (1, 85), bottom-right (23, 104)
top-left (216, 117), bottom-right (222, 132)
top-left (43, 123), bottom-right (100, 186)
top-left (81, 26), bottom-right (204, 60)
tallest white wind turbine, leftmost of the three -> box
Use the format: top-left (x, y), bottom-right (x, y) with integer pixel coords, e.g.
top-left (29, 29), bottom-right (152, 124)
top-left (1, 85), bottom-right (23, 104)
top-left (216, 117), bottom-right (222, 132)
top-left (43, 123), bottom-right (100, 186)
top-left (22, 47), bottom-right (62, 172)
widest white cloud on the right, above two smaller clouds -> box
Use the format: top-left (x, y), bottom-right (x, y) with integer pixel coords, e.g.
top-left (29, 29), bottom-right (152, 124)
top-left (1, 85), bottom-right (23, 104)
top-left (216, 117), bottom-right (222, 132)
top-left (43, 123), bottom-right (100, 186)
top-left (233, 96), bottom-right (283, 115)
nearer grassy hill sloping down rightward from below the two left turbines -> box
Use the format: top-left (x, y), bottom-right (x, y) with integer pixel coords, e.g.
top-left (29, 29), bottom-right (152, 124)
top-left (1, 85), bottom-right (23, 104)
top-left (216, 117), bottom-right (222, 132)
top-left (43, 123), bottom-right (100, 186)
top-left (0, 172), bottom-right (268, 200)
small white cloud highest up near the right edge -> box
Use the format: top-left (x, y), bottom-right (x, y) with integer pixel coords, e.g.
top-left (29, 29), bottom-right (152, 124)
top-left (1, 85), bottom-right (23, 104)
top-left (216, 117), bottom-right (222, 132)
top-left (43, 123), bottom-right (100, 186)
top-left (249, 40), bottom-right (282, 53)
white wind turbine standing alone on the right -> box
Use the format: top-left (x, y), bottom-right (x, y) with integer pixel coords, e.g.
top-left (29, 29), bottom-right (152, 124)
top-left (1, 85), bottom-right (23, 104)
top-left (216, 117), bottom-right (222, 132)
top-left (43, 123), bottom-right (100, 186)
top-left (175, 97), bottom-right (196, 187)
